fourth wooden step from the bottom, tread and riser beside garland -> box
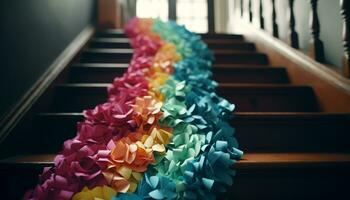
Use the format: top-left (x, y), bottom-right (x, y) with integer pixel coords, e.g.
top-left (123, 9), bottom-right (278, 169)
top-left (70, 63), bottom-right (289, 83)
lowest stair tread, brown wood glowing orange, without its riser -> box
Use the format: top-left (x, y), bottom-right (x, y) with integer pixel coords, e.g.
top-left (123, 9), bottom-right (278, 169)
top-left (0, 153), bottom-right (350, 169)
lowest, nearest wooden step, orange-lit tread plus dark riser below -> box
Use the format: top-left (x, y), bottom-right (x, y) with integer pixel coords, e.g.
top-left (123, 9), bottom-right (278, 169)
top-left (0, 153), bottom-right (350, 199)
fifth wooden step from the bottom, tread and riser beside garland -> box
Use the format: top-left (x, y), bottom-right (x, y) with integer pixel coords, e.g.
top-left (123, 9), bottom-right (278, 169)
top-left (80, 48), bottom-right (268, 64)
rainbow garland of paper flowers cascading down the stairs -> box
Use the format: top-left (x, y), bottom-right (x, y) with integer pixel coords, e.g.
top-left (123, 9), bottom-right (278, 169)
top-left (24, 18), bottom-right (243, 200)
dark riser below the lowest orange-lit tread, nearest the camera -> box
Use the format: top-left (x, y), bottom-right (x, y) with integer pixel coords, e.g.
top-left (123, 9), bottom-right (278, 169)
top-left (0, 165), bottom-right (350, 200)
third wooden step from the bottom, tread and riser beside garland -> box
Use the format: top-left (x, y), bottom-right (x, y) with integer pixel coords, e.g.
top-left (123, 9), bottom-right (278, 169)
top-left (52, 83), bottom-right (319, 112)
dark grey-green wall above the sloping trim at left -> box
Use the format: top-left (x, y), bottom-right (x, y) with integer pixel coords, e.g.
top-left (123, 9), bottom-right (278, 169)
top-left (0, 0), bottom-right (96, 118)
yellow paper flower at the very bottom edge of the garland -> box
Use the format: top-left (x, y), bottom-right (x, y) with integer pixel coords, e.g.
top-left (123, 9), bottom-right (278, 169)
top-left (72, 186), bottom-right (117, 200)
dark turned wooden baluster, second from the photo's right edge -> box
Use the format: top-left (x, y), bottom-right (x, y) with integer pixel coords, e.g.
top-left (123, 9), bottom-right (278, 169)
top-left (310, 0), bottom-right (324, 62)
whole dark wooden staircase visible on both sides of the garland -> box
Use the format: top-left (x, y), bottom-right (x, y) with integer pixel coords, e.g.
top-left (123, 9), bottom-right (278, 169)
top-left (0, 30), bottom-right (350, 199)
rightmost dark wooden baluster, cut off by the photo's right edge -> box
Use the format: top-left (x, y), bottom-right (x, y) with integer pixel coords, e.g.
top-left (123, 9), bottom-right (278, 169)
top-left (340, 0), bottom-right (350, 78)
